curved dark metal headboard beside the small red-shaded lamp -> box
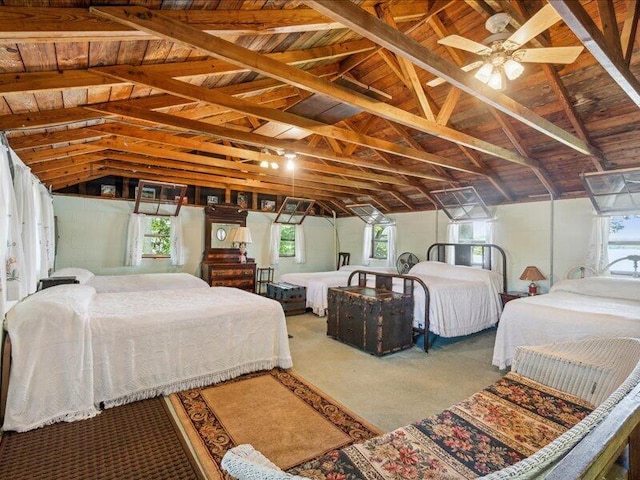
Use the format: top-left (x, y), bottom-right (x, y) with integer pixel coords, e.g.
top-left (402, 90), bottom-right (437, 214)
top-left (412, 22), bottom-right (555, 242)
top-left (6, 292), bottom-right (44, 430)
top-left (427, 243), bottom-right (507, 292)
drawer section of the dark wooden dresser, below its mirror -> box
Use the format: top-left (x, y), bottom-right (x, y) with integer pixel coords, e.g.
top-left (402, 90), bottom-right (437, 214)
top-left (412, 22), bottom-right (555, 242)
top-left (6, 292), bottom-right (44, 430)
top-left (202, 248), bottom-right (256, 292)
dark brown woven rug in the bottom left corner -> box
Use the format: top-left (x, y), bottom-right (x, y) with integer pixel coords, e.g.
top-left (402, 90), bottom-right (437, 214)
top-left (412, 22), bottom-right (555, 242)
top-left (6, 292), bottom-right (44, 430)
top-left (0, 398), bottom-right (202, 480)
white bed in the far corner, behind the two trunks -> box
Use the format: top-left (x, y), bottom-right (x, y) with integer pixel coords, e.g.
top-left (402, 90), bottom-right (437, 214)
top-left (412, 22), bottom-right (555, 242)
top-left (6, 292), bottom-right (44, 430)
top-left (280, 265), bottom-right (398, 317)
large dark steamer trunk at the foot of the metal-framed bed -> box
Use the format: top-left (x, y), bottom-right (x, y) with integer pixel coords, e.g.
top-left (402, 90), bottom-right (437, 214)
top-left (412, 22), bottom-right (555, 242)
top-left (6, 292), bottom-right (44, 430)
top-left (327, 286), bottom-right (413, 355)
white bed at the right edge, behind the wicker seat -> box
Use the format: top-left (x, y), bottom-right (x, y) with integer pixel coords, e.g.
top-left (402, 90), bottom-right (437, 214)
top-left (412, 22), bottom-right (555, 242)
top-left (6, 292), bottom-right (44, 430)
top-left (493, 277), bottom-right (640, 369)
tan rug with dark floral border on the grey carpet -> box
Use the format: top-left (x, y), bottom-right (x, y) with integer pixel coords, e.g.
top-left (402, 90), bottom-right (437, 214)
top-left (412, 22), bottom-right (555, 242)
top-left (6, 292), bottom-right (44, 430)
top-left (170, 369), bottom-right (381, 479)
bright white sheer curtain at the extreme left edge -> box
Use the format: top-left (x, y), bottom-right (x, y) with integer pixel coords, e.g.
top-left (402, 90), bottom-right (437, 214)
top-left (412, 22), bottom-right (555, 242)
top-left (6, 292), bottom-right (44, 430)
top-left (0, 145), bottom-right (27, 315)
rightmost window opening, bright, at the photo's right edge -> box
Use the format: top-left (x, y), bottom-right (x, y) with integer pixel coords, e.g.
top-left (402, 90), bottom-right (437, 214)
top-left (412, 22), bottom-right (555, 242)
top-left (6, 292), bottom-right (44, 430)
top-left (607, 215), bottom-right (640, 275)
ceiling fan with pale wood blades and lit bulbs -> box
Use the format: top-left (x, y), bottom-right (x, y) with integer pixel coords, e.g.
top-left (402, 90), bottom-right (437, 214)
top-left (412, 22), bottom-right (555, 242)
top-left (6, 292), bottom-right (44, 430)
top-left (427, 4), bottom-right (584, 90)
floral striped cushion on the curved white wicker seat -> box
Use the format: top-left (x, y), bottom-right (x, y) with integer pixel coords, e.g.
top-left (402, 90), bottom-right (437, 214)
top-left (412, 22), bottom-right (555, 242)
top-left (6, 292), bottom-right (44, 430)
top-left (289, 373), bottom-right (592, 480)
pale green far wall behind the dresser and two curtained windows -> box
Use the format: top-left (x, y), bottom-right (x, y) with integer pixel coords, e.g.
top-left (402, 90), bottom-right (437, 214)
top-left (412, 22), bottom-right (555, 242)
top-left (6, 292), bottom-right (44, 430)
top-left (53, 195), bottom-right (335, 279)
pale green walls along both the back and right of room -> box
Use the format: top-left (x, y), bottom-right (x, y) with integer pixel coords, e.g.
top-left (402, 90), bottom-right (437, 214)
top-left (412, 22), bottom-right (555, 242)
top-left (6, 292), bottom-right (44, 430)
top-left (54, 195), bottom-right (593, 292)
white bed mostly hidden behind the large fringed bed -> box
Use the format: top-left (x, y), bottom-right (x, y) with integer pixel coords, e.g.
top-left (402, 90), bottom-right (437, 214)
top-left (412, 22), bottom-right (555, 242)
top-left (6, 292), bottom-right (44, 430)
top-left (51, 267), bottom-right (209, 293)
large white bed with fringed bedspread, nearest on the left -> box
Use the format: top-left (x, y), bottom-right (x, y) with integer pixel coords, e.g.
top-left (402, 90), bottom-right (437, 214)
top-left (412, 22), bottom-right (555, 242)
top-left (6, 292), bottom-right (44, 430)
top-left (4, 285), bottom-right (292, 431)
